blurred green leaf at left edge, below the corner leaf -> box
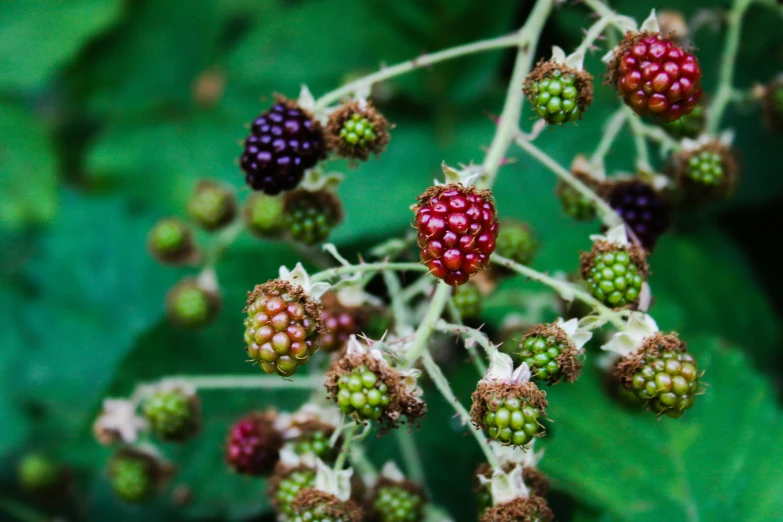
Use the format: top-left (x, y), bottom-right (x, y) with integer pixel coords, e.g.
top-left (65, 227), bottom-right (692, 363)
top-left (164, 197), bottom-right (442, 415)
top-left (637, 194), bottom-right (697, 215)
top-left (0, 102), bottom-right (57, 228)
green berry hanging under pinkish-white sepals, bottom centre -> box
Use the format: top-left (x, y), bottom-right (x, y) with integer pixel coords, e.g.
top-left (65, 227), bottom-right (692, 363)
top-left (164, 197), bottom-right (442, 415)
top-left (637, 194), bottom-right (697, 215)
top-left (471, 380), bottom-right (547, 446)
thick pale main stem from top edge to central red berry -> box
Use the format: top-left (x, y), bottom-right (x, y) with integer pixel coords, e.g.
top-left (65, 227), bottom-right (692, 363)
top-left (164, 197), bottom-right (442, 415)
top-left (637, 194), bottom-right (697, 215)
top-left (481, 0), bottom-right (554, 188)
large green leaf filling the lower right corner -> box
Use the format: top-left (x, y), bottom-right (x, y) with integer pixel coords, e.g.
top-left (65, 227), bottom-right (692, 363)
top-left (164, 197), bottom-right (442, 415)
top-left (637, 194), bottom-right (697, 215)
top-left (542, 338), bottom-right (783, 522)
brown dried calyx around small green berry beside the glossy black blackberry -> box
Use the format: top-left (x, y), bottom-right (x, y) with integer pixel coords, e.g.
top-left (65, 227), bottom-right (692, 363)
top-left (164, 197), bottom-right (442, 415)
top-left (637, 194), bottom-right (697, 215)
top-left (326, 100), bottom-right (392, 161)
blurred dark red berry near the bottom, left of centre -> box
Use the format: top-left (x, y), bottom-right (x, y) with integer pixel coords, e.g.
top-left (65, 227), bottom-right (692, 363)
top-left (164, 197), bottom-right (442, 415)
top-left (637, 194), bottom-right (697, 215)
top-left (226, 413), bottom-right (283, 476)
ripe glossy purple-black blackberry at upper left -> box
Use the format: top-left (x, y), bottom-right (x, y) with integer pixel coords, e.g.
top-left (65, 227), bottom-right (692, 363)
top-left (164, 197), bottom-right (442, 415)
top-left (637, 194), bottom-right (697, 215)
top-left (239, 97), bottom-right (326, 195)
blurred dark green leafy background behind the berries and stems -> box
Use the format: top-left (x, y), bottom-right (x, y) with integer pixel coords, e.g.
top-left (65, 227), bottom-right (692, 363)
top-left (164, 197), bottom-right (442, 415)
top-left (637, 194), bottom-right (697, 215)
top-left (0, 0), bottom-right (783, 522)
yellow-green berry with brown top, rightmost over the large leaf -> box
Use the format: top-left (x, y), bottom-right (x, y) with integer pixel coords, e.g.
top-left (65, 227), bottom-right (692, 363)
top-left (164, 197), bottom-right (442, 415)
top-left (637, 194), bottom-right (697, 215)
top-left (617, 333), bottom-right (700, 418)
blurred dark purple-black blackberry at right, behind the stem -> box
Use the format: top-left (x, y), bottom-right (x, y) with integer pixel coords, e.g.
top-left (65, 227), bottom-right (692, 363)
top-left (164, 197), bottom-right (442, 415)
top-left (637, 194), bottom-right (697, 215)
top-left (607, 180), bottom-right (671, 252)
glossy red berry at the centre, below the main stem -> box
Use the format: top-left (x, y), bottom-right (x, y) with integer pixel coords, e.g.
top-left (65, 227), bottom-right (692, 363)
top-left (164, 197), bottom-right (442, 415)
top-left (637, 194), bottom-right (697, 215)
top-left (414, 184), bottom-right (498, 286)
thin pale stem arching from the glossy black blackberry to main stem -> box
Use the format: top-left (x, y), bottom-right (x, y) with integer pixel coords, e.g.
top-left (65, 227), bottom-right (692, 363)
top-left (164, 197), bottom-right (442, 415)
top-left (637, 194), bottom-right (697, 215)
top-left (315, 33), bottom-right (518, 109)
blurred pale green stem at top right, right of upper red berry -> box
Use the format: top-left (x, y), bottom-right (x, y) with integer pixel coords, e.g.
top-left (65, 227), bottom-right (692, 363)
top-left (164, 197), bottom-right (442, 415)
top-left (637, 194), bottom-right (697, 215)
top-left (707, 0), bottom-right (753, 135)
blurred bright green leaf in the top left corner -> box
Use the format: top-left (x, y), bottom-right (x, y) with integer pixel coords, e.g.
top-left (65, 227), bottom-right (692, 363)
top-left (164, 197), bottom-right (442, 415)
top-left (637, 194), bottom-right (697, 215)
top-left (0, 0), bottom-right (123, 90)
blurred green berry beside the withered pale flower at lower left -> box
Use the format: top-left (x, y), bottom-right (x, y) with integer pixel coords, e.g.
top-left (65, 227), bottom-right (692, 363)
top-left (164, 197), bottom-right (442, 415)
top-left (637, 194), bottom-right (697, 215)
top-left (144, 389), bottom-right (201, 442)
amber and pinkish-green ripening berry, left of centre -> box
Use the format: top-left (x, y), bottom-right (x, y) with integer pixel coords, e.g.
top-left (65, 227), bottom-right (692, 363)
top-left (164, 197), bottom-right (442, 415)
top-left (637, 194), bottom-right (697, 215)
top-left (245, 280), bottom-right (320, 377)
